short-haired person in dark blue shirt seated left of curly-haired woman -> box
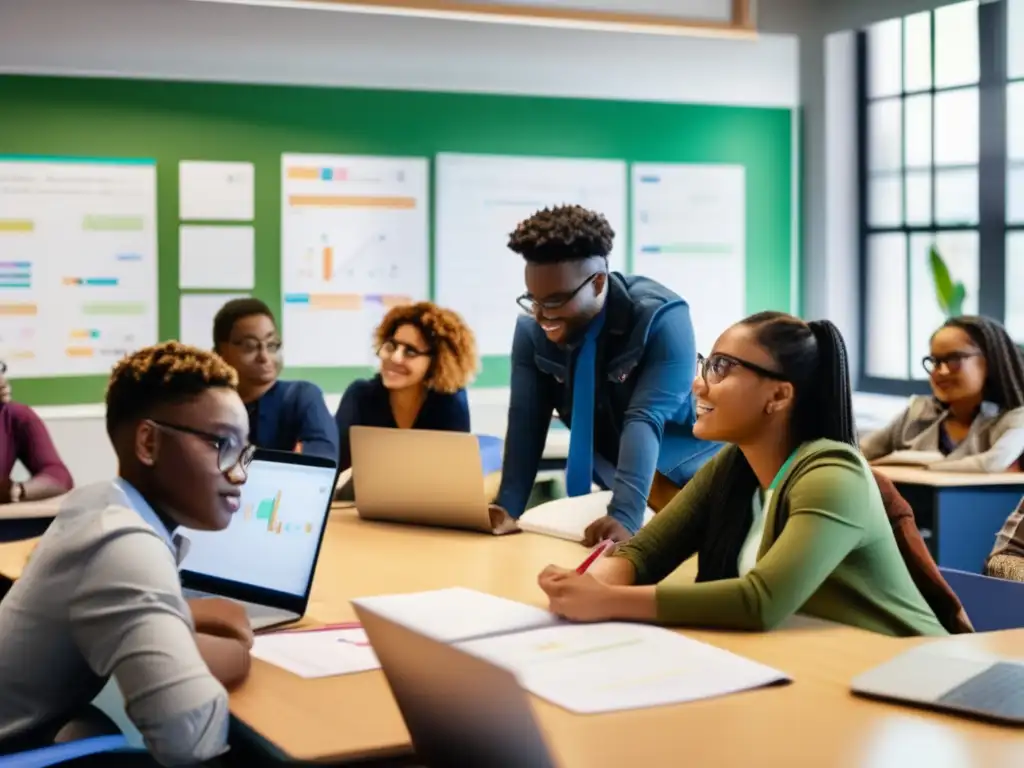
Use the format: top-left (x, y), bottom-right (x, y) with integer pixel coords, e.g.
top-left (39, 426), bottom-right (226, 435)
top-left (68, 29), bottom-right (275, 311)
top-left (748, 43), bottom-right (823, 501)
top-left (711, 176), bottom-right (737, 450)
top-left (213, 299), bottom-right (338, 460)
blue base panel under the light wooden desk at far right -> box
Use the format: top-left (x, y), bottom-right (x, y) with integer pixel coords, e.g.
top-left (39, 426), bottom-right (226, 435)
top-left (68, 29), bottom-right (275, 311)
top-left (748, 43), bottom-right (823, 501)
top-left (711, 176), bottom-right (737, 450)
top-left (933, 485), bottom-right (1021, 573)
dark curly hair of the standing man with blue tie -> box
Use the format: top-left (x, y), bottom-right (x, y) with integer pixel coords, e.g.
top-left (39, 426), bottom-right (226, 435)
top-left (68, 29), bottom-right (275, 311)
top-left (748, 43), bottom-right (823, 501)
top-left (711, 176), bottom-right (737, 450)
top-left (509, 205), bottom-right (615, 264)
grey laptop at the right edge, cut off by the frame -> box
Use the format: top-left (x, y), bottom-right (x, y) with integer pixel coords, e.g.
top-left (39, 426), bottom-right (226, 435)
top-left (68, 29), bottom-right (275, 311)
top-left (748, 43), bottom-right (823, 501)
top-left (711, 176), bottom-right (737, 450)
top-left (852, 641), bottom-right (1024, 726)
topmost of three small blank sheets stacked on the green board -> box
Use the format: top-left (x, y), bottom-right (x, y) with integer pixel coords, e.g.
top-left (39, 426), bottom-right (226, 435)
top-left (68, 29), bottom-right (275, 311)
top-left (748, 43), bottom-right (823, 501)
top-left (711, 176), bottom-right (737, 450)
top-left (178, 160), bottom-right (256, 221)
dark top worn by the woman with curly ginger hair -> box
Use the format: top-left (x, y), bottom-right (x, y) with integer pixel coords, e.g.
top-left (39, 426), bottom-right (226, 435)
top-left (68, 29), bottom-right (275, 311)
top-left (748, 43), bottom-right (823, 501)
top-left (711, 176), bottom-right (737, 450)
top-left (334, 375), bottom-right (470, 471)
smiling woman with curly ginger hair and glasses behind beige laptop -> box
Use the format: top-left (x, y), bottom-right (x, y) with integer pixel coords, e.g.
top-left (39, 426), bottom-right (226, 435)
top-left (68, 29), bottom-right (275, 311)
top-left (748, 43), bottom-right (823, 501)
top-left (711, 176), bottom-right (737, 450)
top-left (334, 301), bottom-right (479, 471)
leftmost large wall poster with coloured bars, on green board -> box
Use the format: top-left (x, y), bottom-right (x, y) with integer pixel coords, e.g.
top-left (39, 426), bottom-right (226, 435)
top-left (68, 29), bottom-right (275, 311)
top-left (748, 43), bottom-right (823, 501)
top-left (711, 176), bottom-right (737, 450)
top-left (0, 158), bottom-right (158, 377)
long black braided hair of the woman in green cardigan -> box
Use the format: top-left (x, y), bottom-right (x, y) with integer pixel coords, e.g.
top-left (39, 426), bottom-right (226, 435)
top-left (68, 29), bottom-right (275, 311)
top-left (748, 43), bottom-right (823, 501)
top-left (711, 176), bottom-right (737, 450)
top-left (697, 312), bottom-right (857, 582)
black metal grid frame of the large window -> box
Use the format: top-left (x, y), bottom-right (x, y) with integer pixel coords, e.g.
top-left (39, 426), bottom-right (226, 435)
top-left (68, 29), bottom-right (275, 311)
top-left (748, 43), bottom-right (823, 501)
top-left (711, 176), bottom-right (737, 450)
top-left (856, 0), bottom-right (1007, 396)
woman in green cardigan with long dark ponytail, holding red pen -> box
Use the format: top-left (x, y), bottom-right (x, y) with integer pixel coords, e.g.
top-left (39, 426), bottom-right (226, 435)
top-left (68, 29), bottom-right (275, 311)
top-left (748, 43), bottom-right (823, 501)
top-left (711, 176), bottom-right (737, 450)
top-left (540, 312), bottom-right (946, 635)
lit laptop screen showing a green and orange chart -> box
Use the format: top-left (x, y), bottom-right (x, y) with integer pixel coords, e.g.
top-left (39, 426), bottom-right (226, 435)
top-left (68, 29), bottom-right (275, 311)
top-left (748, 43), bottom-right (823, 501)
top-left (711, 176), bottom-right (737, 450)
top-left (181, 452), bottom-right (337, 597)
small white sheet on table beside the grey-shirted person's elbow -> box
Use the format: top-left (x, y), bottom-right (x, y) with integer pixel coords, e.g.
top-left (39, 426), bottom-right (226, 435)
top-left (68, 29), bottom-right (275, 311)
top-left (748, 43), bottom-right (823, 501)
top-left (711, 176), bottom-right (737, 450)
top-left (252, 629), bottom-right (380, 678)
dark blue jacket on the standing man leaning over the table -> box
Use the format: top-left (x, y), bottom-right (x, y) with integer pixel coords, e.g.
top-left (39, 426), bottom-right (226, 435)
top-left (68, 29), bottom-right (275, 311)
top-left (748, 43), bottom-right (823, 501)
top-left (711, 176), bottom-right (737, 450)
top-left (498, 272), bottom-right (720, 532)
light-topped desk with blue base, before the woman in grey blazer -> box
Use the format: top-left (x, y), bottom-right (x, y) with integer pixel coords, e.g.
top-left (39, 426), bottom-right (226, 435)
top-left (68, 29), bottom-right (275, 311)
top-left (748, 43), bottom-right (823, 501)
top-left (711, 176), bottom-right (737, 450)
top-left (873, 466), bottom-right (1024, 573)
